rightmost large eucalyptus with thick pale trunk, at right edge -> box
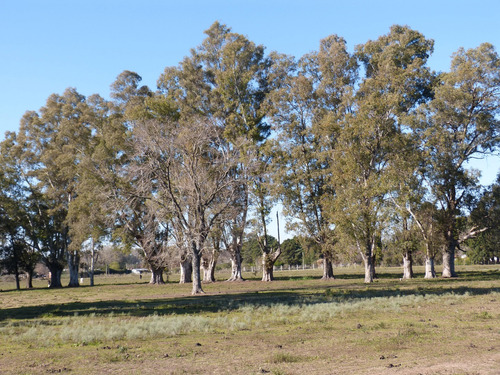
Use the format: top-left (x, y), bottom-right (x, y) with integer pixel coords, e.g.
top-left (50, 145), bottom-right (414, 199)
top-left (415, 43), bottom-right (500, 277)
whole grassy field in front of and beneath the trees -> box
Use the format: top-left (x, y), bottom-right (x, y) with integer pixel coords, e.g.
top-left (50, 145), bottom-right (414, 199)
top-left (0, 266), bottom-right (500, 375)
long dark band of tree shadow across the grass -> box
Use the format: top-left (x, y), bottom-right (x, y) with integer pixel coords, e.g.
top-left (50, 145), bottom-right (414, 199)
top-left (0, 271), bottom-right (500, 322)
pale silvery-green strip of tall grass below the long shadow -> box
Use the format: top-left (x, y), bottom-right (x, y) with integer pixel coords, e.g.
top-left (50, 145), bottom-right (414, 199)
top-left (0, 292), bottom-right (500, 345)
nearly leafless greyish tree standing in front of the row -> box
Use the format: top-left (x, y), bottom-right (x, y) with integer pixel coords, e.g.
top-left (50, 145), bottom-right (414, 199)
top-left (134, 118), bottom-right (239, 294)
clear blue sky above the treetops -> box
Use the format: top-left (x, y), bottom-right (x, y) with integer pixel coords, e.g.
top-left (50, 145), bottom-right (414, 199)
top-left (0, 0), bottom-right (500, 188)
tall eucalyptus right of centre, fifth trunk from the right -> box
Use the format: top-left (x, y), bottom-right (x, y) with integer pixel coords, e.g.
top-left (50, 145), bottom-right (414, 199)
top-left (270, 35), bottom-right (357, 280)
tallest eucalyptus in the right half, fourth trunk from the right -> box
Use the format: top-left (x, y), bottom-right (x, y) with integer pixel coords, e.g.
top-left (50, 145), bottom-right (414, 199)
top-left (331, 26), bottom-right (433, 283)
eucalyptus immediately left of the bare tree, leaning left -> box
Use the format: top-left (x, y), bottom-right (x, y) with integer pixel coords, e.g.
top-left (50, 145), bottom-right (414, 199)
top-left (99, 71), bottom-right (176, 284)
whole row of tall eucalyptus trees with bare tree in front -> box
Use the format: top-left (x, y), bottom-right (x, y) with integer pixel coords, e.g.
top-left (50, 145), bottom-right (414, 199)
top-left (0, 22), bottom-right (500, 294)
